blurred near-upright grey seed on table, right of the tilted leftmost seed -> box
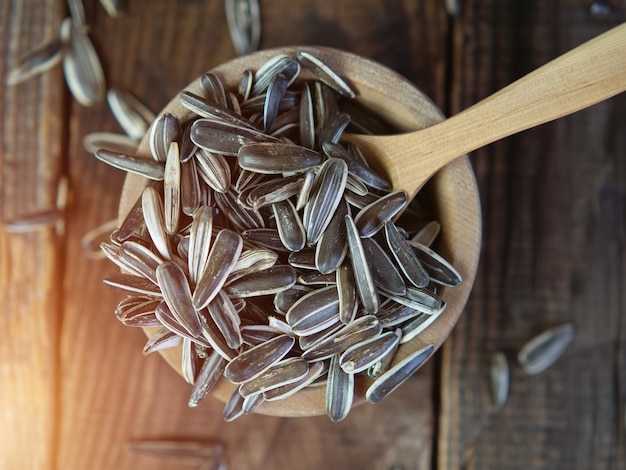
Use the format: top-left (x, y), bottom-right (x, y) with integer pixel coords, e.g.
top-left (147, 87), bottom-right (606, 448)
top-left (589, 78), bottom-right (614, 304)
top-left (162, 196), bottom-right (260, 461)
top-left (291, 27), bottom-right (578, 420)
top-left (61, 18), bottom-right (106, 106)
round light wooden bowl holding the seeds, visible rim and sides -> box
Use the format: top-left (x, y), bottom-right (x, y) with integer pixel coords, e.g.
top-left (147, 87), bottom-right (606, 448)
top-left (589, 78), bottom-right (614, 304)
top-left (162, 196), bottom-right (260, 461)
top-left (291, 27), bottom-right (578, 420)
top-left (119, 47), bottom-right (481, 417)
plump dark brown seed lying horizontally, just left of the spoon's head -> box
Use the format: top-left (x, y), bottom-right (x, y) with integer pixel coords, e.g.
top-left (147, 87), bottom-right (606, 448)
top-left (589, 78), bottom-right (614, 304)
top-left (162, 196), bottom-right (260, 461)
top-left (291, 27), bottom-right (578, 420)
top-left (237, 142), bottom-right (324, 174)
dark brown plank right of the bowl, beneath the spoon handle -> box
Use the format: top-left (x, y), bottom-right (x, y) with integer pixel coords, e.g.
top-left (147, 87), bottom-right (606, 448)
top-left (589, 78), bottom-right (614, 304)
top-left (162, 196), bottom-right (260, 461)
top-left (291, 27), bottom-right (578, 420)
top-left (438, 0), bottom-right (626, 469)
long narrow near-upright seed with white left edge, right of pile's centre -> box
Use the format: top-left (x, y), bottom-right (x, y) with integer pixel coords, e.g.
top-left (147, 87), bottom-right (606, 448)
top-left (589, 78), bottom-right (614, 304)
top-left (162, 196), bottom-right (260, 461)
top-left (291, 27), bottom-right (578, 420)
top-left (345, 215), bottom-right (380, 313)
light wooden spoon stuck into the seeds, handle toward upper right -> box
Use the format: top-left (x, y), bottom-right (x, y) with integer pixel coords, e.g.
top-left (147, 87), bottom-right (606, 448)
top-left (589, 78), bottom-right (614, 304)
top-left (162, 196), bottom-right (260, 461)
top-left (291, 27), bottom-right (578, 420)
top-left (344, 23), bottom-right (626, 197)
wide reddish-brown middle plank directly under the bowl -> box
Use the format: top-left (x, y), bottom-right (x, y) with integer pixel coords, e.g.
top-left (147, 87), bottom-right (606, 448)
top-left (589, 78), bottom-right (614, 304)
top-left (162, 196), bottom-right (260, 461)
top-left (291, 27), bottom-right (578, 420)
top-left (57, 0), bottom-right (447, 469)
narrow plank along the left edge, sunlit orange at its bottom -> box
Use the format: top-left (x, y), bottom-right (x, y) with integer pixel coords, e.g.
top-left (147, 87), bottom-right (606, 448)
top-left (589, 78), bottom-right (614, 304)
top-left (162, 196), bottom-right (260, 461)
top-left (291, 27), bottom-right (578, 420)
top-left (0, 0), bottom-right (64, 469)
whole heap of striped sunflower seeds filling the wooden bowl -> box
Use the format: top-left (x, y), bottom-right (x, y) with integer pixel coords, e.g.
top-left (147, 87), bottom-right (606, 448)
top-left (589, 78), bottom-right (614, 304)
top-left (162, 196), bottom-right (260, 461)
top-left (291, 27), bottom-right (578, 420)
top-left (95, 51), bottom-right (461, 421)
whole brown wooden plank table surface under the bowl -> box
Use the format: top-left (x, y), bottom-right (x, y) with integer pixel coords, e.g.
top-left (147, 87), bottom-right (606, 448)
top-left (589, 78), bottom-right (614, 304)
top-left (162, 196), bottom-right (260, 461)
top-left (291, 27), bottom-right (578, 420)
top-left (0, 0), bottom-right (626, 470)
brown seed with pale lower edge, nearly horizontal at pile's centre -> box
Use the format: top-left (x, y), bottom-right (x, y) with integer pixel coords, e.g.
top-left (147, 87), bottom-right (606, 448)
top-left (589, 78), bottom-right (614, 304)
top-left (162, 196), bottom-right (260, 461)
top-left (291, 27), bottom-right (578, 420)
top-left (224, 265), bottom-right (296, 298)
